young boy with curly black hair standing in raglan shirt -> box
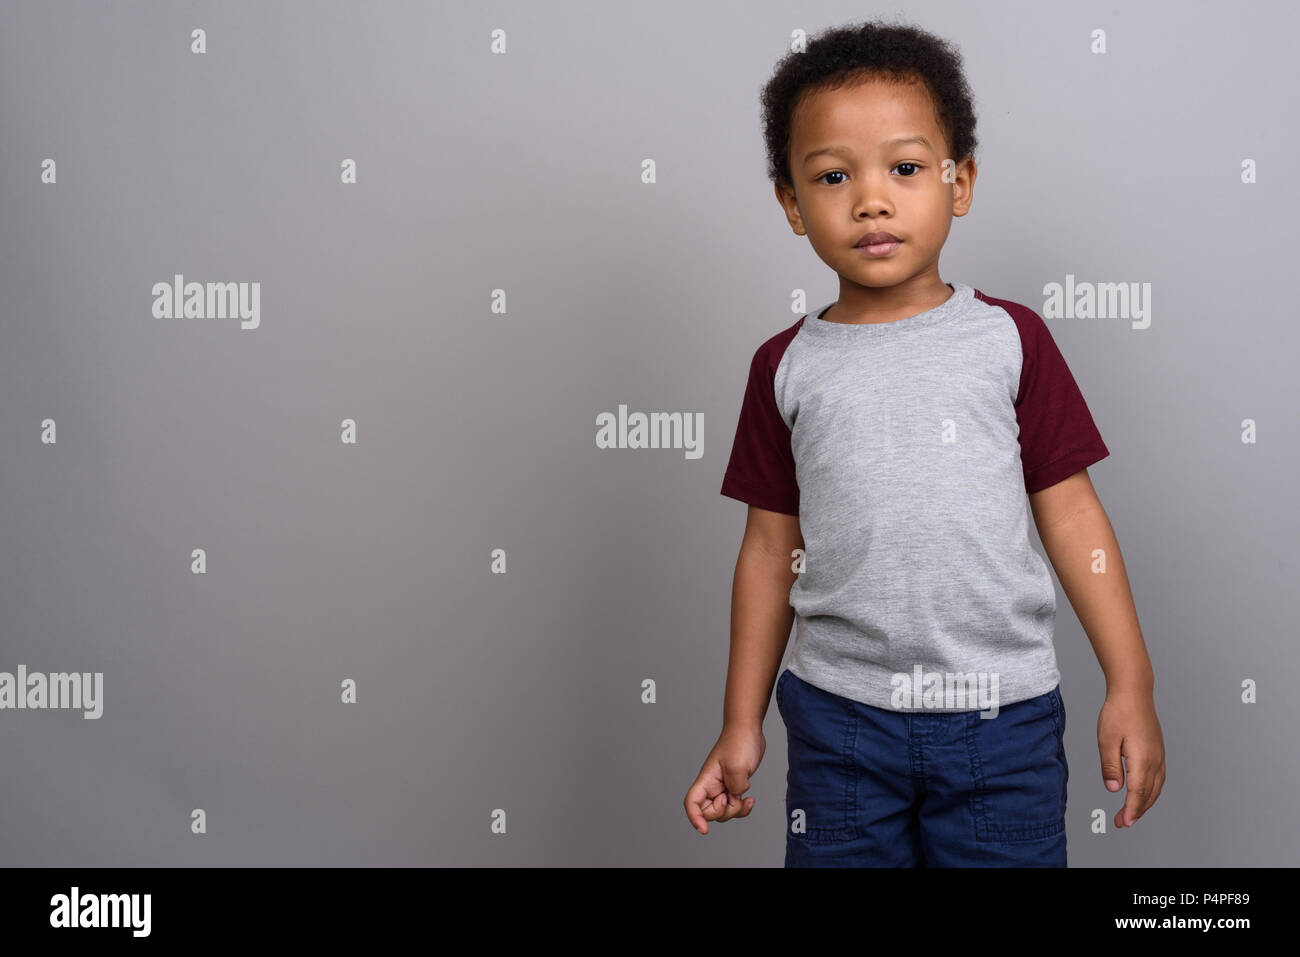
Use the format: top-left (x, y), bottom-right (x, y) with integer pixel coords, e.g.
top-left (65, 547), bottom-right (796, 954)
top-left (685, 23), bottom-right (1165, 867)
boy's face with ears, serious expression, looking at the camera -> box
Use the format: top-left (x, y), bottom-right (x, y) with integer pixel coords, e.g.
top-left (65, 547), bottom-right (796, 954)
top-left (776, 79), bottom-right (976, 302)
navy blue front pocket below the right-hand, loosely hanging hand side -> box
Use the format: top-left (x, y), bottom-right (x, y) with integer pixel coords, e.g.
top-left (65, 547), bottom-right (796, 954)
top-left (966, 689), bottom-right (1070, 844)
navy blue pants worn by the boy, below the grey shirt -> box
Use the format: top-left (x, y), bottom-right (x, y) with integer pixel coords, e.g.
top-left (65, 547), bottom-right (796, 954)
top-left (776, 668), bottom-right (1070, 867)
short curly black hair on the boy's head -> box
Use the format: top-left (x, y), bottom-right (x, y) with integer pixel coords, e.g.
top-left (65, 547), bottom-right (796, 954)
top-left (762, 20), bottom-right (978, 186)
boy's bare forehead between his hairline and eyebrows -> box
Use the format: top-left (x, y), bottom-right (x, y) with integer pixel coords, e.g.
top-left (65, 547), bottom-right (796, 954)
top-left (790, 79), bottom-right (943, 151)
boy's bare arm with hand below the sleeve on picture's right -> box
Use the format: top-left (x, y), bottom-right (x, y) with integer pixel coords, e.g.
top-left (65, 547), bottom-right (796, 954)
top-left (1030, 469), bottom-right (1165, 827)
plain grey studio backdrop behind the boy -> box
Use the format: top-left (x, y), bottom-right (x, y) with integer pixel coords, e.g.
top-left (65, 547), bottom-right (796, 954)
top-left (0, 1), bottom-right (1300, 866)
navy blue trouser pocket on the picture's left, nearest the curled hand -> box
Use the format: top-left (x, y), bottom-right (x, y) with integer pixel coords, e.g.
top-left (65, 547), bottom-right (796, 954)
top-left (780, 671), bottom-right (858, 844)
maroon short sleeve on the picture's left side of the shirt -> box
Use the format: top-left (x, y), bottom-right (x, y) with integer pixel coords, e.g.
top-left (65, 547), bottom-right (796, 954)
top-left (722, 319), bottom-right (803, 515)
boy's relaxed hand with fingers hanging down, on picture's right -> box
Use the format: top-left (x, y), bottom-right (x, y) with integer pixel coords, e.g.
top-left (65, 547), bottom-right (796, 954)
top-left (1097, 692), bottom-right (1165, 827)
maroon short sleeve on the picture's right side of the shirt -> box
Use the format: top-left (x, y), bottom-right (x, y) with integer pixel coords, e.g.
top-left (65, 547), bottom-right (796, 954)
top-left (1008, 306), bottom-right (1110, 493)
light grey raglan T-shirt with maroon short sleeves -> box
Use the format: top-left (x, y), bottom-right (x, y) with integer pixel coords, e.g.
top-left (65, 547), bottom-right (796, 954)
top-left (722, 282), bottom-right (1110, 710)
